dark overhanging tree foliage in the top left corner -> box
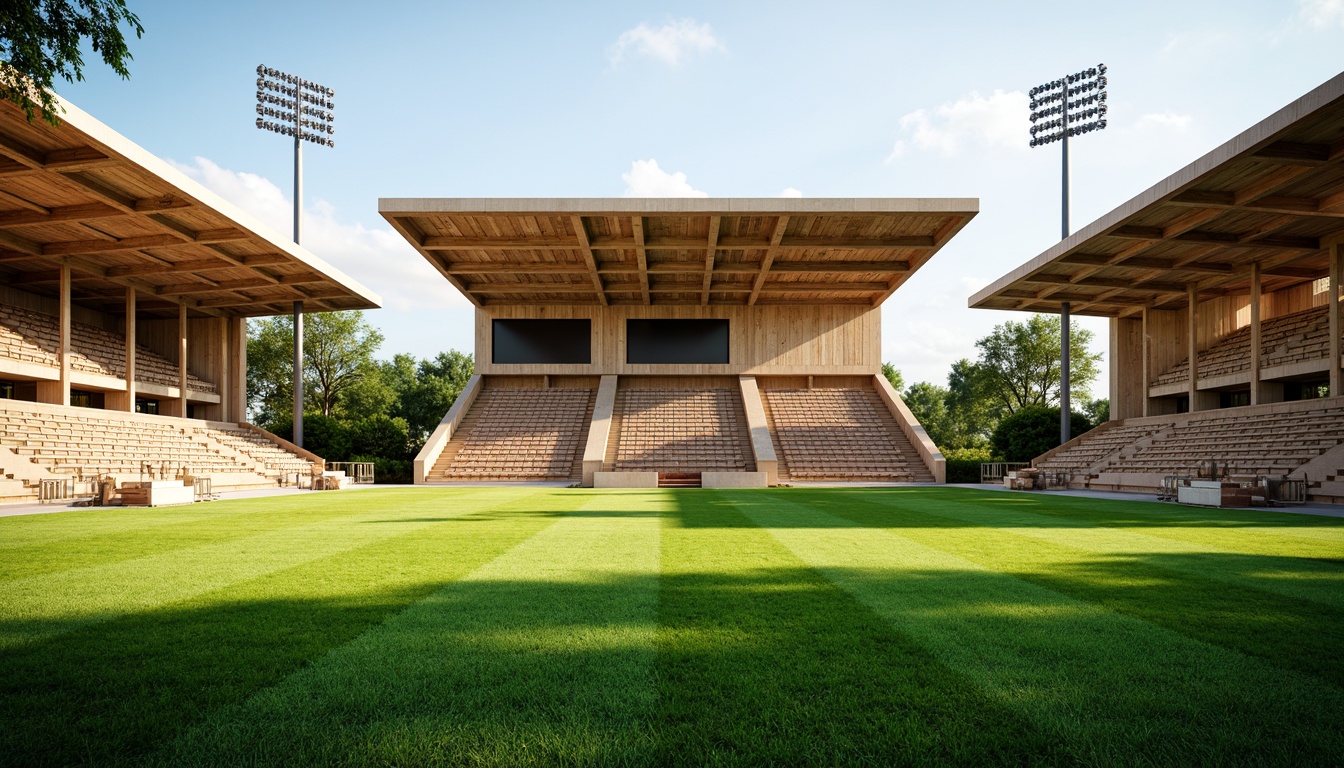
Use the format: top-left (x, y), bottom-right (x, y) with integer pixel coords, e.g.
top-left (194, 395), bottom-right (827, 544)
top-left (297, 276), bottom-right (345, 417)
top-left (0, 0), bottom-right (145, 125)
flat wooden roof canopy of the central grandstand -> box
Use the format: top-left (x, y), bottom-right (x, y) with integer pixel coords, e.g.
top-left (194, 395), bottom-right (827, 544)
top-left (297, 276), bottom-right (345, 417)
top-left (379, 198), bottom-right (980, 307)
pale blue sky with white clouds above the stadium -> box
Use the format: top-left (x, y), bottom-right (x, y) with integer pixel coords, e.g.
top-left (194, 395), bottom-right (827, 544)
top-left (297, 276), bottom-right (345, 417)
top-left (58, 0), bottom-right (1344, 395)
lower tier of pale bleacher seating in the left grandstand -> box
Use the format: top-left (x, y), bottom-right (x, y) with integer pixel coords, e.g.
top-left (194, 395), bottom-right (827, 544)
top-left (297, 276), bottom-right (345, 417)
top-left (0, 401), bottom-right (312, 488)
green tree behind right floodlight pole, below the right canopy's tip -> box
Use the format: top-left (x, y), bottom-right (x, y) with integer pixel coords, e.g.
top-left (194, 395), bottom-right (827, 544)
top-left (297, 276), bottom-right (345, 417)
top-left (976, 315), bottom-right (1101, 413)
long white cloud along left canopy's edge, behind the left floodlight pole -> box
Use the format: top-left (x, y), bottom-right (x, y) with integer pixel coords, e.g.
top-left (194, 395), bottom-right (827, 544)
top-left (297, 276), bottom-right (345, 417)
top-left (169, 157), bottom-right (468, 309)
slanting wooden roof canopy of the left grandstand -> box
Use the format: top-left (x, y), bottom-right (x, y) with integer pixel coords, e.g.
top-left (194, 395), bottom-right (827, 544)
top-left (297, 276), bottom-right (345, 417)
top-left (0, 94), bottom-right (380, 317)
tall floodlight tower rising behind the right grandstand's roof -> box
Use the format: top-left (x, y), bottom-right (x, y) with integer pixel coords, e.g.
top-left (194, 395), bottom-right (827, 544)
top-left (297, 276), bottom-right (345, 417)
top-left (1030, 65), bottom-right (1107, 445)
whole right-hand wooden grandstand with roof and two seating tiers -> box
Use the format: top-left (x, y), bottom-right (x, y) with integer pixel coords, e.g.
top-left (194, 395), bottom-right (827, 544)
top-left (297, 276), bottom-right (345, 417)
top-left (970, 75), bottom-right (1344, 500)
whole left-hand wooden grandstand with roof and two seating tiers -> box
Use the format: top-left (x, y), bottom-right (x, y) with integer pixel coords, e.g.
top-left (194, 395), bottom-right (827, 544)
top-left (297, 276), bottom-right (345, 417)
top-left (0, 91), bottom-right (379, 500)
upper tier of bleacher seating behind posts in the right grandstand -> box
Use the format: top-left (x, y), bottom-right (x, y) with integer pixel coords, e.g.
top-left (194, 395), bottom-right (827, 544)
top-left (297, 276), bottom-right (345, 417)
top-left (1153, 307), bottom-right (1329, 386)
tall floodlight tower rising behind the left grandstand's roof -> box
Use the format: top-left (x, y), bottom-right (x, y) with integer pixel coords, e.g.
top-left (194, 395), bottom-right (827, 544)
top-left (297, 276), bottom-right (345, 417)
top-left (257, 65), bottom-right (336, 448)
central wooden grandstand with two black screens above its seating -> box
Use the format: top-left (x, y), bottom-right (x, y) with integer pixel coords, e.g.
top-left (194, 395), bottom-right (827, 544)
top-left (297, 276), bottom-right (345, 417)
top-left (379, 198), bottom-right (978, 487)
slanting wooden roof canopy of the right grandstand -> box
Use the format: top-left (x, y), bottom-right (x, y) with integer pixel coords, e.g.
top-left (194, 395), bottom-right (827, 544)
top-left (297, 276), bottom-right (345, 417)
top-left (970, 74), bottom-right (1344, 317)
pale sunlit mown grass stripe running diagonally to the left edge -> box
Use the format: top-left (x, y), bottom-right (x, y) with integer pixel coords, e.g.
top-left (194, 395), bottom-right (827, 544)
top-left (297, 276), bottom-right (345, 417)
top-left (0, 490), bottom-right (538, 648)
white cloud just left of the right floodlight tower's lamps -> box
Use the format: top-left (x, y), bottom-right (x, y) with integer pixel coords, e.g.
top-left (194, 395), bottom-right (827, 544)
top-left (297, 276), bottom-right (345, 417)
top-left (887, 90), bottom-right (1031, 163)
